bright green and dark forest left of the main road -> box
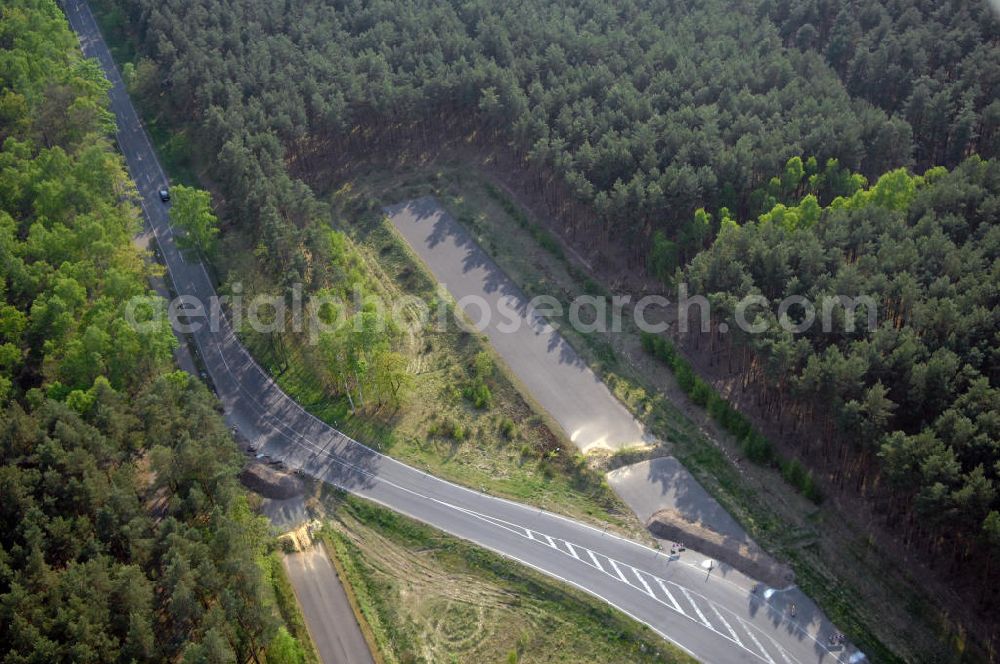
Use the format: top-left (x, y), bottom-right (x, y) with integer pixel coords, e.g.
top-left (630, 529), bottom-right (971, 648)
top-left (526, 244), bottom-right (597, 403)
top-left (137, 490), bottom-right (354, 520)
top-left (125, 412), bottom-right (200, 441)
top-left (0, 0), bottom-right (306, 663)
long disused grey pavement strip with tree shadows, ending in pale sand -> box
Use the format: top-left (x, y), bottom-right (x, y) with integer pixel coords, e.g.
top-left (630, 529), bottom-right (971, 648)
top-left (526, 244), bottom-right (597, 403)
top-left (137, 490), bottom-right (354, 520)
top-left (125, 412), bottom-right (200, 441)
top-left (386, 197), bottom-right (646, 452)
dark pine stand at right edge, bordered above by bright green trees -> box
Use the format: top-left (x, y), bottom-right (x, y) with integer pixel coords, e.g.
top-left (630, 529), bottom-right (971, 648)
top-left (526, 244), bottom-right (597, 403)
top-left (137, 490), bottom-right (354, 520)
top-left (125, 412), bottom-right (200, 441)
top-left (683, 157), bottom-right (1000, 576)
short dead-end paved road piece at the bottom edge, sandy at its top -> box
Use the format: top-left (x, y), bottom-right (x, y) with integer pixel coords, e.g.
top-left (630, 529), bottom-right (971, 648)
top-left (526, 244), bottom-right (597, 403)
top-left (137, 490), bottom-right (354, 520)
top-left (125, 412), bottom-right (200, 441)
top-left (284, 543), bottom-right (375, 664)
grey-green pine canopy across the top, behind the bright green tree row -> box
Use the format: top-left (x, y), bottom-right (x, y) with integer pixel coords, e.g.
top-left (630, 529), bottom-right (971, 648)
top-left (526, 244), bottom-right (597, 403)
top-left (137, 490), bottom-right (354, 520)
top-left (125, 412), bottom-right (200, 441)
top-left (103, 0), bottom-right (1000, 272)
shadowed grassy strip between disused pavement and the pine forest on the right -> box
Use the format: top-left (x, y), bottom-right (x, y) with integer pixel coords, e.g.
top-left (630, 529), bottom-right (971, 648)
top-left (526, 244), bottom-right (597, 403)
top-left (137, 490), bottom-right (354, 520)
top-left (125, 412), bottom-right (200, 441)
top-left (322, 157), bottom-right (976, 662)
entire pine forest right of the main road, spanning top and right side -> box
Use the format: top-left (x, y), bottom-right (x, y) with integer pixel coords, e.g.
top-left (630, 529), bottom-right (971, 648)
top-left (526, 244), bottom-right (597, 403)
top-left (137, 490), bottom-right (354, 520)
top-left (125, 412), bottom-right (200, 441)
top-left (56, 0), bottom-right (1000, 656)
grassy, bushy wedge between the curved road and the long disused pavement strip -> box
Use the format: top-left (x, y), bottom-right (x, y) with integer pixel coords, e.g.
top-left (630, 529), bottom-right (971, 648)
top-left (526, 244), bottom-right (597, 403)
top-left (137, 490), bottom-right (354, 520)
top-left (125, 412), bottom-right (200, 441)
top-left (218, 190), bottom-right (640, 534)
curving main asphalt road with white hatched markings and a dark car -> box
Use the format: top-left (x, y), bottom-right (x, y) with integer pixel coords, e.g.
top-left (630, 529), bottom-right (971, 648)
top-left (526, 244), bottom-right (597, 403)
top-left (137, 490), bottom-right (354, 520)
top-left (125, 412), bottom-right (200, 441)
top-left (64, 0), bottom-right (864, 664)
